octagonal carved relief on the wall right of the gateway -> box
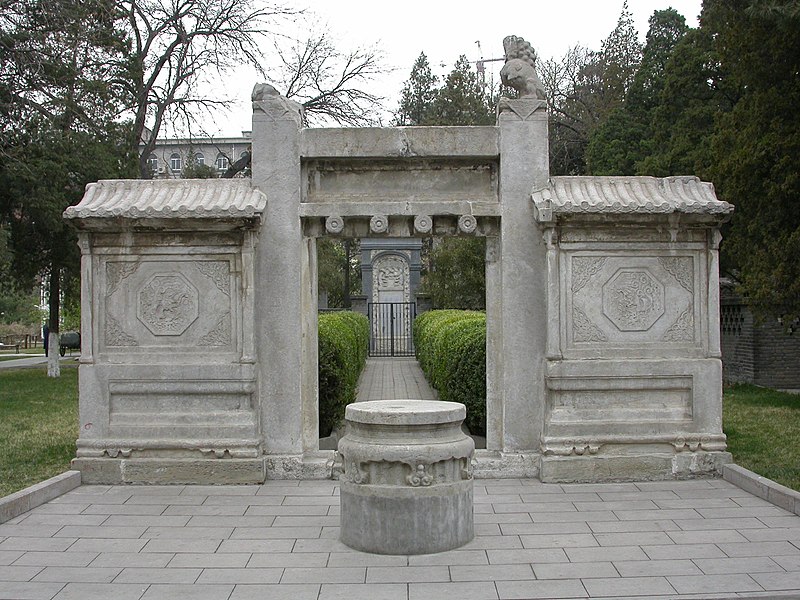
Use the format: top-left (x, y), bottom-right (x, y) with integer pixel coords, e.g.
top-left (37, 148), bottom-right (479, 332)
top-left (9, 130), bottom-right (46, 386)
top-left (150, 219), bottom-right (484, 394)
top-left (603, 268), bottom-right (664, 331)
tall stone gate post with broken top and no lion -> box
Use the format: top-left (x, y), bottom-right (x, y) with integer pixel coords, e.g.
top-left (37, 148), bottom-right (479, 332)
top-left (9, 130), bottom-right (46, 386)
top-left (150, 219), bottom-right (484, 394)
top-left (252, 84), bottom-right (317, 478)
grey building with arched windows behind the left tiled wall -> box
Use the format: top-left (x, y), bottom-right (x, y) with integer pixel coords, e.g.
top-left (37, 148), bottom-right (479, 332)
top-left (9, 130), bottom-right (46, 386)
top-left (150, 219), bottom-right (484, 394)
top-left (141, 131), bottom-right (251, 179)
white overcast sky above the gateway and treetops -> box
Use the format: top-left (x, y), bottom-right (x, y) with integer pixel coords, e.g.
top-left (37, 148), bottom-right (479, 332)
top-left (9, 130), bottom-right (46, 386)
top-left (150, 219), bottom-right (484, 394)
top-left (204, 0), bottom-right (701, 136)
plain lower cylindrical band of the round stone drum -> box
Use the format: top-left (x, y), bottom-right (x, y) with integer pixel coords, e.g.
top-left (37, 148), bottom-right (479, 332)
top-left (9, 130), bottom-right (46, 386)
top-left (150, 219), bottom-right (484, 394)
top-left (341, 479), bottom-right (475, 554)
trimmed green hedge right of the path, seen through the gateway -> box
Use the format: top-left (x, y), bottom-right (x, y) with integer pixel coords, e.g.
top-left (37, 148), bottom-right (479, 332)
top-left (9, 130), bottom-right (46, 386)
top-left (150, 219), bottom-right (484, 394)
top-left (414, 310), bottom-right (486, 435)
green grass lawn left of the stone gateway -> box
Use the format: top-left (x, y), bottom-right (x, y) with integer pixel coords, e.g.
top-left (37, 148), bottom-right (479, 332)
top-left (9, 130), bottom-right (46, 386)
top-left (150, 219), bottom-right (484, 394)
top-left (0, 365), bottom-right (78, 497)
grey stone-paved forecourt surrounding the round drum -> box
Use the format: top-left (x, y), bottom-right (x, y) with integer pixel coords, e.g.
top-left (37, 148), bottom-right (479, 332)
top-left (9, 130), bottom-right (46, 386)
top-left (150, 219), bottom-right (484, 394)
top-left (0, 479), bottom-right (800, 600)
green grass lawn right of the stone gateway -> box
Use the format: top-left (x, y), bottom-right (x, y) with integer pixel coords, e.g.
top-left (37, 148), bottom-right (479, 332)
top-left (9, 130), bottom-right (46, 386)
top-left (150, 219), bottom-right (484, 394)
top-left (722, 385), bottom-right (800, 491)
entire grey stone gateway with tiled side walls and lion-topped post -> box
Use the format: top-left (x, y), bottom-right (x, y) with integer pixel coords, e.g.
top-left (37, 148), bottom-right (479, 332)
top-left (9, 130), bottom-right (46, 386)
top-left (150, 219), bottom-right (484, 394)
top-left (65, 38), bottom-right (733, 483)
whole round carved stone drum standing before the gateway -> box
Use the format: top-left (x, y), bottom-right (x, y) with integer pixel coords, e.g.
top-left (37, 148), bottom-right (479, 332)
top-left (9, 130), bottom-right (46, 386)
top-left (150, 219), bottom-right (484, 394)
top-left (339, 400), bottom-right (475, 554)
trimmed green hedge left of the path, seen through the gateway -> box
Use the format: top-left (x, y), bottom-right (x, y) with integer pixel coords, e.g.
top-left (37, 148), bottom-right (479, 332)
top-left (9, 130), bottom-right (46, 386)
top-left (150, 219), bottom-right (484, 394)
top-left (319, 311), bottom-right (369, 437)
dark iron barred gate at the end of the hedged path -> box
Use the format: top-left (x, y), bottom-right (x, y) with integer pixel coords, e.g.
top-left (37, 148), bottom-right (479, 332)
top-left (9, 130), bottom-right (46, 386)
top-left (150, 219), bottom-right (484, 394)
top-left (367, 302), bottom-right (417, 356)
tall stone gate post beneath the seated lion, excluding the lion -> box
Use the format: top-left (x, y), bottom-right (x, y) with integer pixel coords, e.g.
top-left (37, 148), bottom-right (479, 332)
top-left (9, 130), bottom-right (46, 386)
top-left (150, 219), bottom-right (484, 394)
top-left (490, 97), bottom-right (549, 464)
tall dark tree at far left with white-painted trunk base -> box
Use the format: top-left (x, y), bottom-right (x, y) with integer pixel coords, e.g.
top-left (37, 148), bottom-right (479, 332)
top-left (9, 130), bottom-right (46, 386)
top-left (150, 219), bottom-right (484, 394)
top-left (0, 0), bottom-right (134, 376)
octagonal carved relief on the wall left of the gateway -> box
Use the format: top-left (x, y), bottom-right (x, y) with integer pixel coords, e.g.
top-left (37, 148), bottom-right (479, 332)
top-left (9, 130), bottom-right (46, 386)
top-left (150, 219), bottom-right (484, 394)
top-left (136, 273), bottom-right (199, 336)
